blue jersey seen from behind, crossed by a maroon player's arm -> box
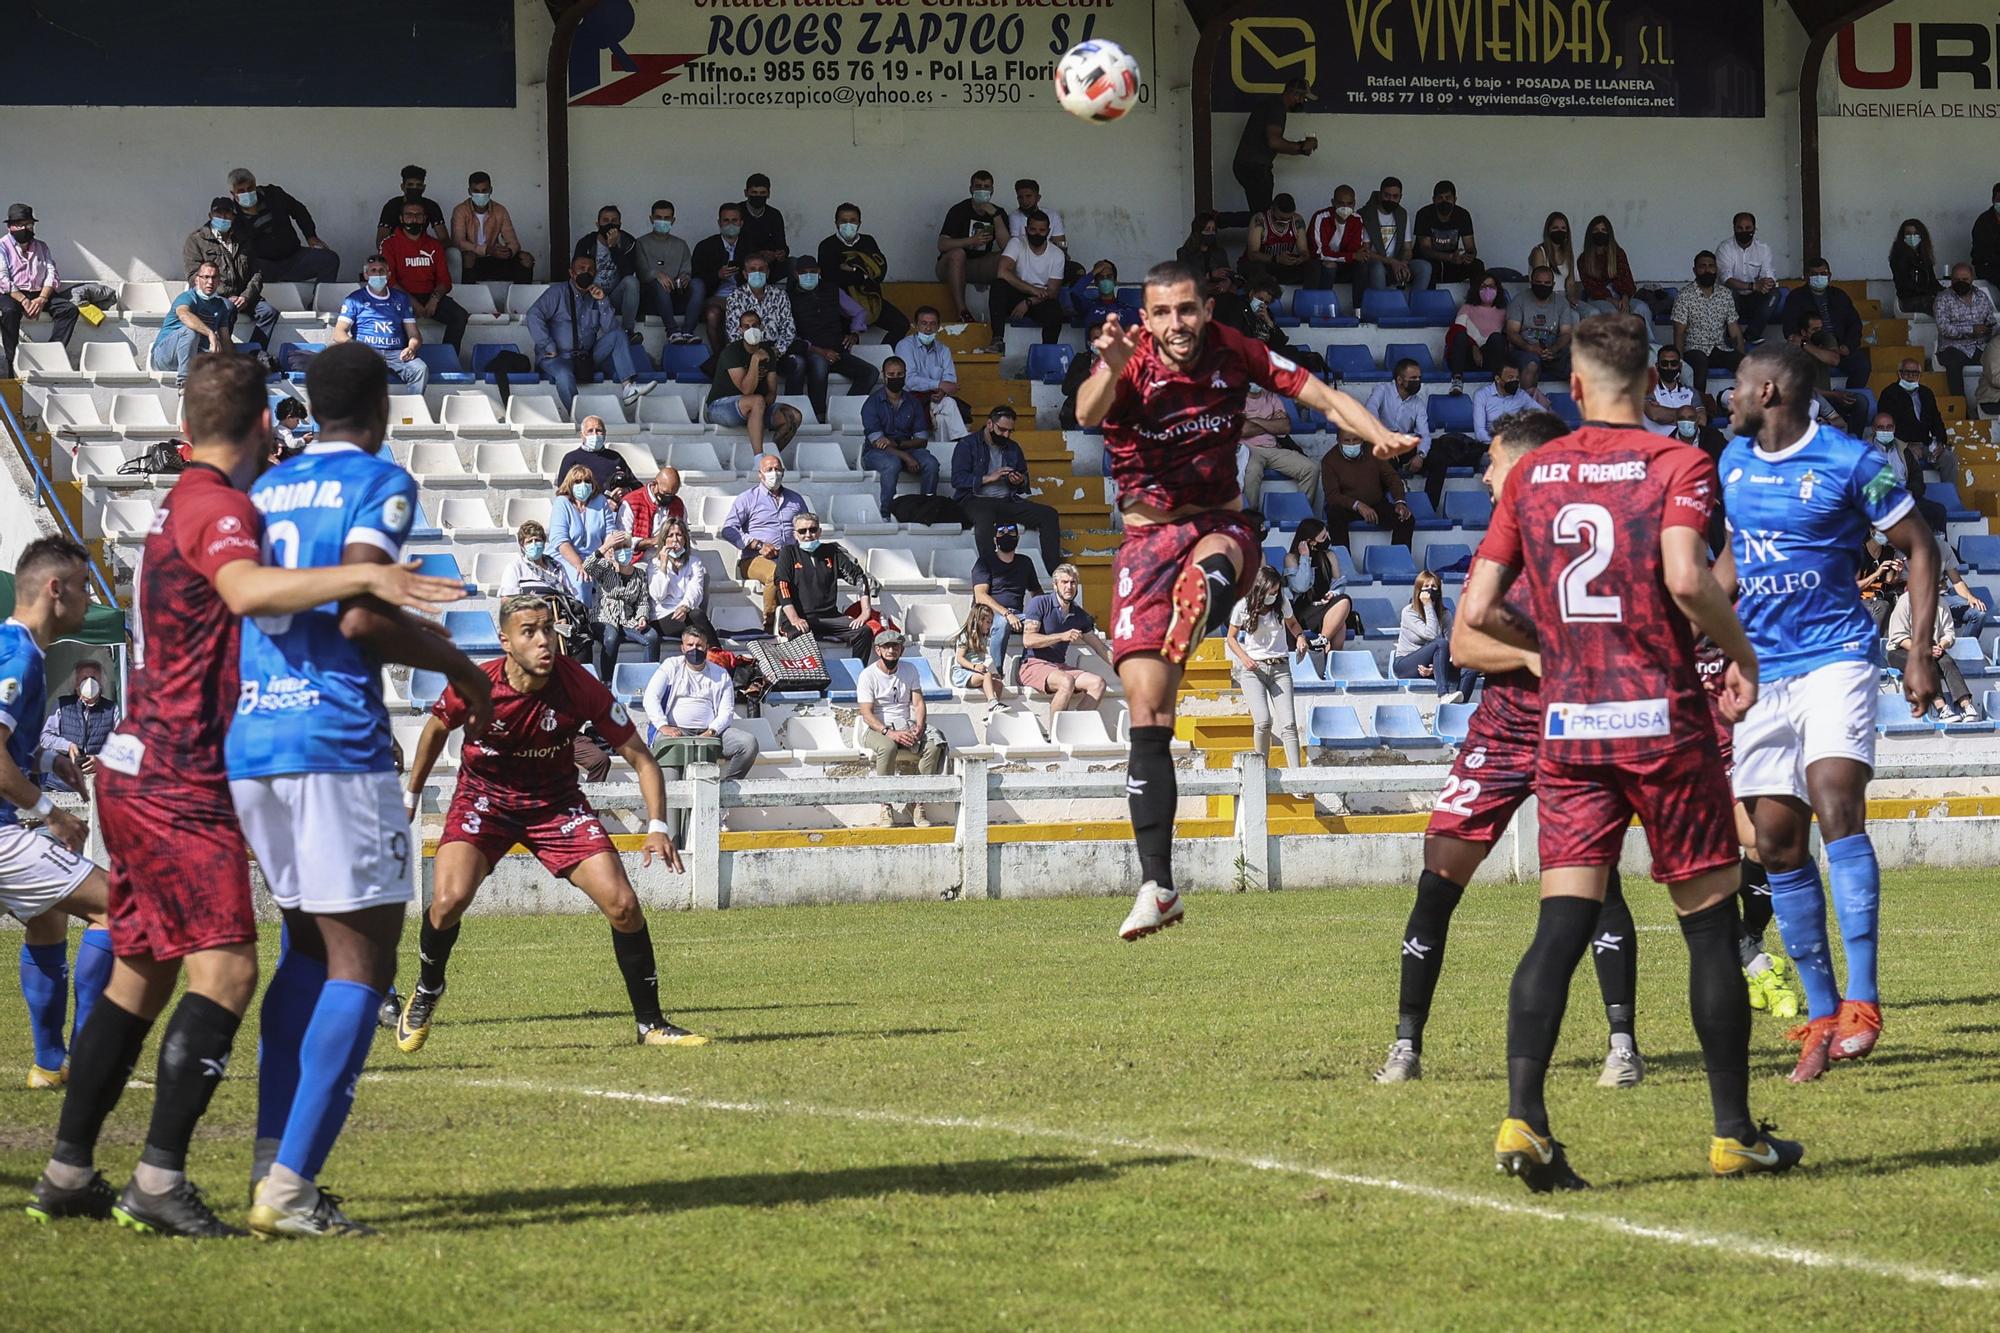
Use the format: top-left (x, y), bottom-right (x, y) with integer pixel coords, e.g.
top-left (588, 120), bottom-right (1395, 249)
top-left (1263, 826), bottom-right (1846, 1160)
top-left (224, 442), bottom-right (416, 779)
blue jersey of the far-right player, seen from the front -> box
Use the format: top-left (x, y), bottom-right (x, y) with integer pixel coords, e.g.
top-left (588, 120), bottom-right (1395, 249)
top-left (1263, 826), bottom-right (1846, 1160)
top-left (1722, 426), bottom-right (1916, 681)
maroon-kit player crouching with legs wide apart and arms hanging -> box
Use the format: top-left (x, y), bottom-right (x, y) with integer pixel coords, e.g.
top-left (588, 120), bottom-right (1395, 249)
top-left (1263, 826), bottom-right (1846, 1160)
top-left (396, 596), bottom-right (708, 1053)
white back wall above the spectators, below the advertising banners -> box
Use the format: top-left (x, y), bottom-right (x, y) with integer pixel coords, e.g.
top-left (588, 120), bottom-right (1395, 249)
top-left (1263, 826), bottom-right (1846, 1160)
top-left (0, 0), bottom-right (2000, 290)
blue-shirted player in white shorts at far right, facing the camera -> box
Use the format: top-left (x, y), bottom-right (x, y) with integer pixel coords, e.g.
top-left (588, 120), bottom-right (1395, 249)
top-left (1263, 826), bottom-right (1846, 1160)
top-left (1720, 342), bottom-right (1938, 1083)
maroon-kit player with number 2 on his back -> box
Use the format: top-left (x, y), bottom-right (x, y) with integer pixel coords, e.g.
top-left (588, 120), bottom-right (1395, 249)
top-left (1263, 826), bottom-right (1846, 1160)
top-left (1460, 314), bottom-right (1804, 1191)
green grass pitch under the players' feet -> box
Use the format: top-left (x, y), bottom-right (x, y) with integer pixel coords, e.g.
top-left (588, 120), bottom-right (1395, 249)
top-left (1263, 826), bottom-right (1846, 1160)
top-left (0, 860), bottom-right (2000, 1329)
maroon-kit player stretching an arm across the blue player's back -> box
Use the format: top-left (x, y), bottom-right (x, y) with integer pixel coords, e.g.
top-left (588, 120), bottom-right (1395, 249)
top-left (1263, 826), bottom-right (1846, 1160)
top-left (28, 354), bottom-right (464, 1237)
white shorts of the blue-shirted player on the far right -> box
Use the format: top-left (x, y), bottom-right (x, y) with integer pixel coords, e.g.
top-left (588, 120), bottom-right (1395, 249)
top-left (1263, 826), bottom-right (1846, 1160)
top-left (1734, 662), bottom-right (1882, 801)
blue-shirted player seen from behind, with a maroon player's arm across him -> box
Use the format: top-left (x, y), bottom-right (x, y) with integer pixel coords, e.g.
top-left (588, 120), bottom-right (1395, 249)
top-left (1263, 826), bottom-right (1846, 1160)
top-left (224, 344), bottom-right (492, 1237)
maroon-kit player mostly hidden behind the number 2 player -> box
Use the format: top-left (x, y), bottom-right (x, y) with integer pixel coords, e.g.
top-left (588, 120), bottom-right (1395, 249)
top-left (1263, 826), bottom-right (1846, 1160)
top-left (1374, 412), bottom-right (1646, 1087)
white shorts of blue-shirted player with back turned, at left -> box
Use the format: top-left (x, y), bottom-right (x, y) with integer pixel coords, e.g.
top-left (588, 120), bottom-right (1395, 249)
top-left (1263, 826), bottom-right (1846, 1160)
top-left (230, 773), bottom-right (412, 917)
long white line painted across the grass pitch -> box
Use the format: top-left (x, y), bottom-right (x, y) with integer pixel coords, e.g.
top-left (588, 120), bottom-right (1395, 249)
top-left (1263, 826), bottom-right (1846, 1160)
top-left (460, 1079), bottom-right (2000, 1291)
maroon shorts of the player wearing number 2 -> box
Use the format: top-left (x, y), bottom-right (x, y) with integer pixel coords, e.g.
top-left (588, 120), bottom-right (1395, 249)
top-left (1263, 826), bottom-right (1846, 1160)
top-left (1536, 737), bottom-right (1738, 885)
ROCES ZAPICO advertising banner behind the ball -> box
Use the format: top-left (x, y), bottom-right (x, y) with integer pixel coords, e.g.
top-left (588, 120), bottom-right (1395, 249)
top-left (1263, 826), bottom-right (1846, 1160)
top-left (570, 0), bottom-right (1156, 114)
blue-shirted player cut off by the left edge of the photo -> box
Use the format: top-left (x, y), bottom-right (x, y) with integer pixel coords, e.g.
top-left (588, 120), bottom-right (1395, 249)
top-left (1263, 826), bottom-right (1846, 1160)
top-left (0, 536), bottom-right (112, 1087)
